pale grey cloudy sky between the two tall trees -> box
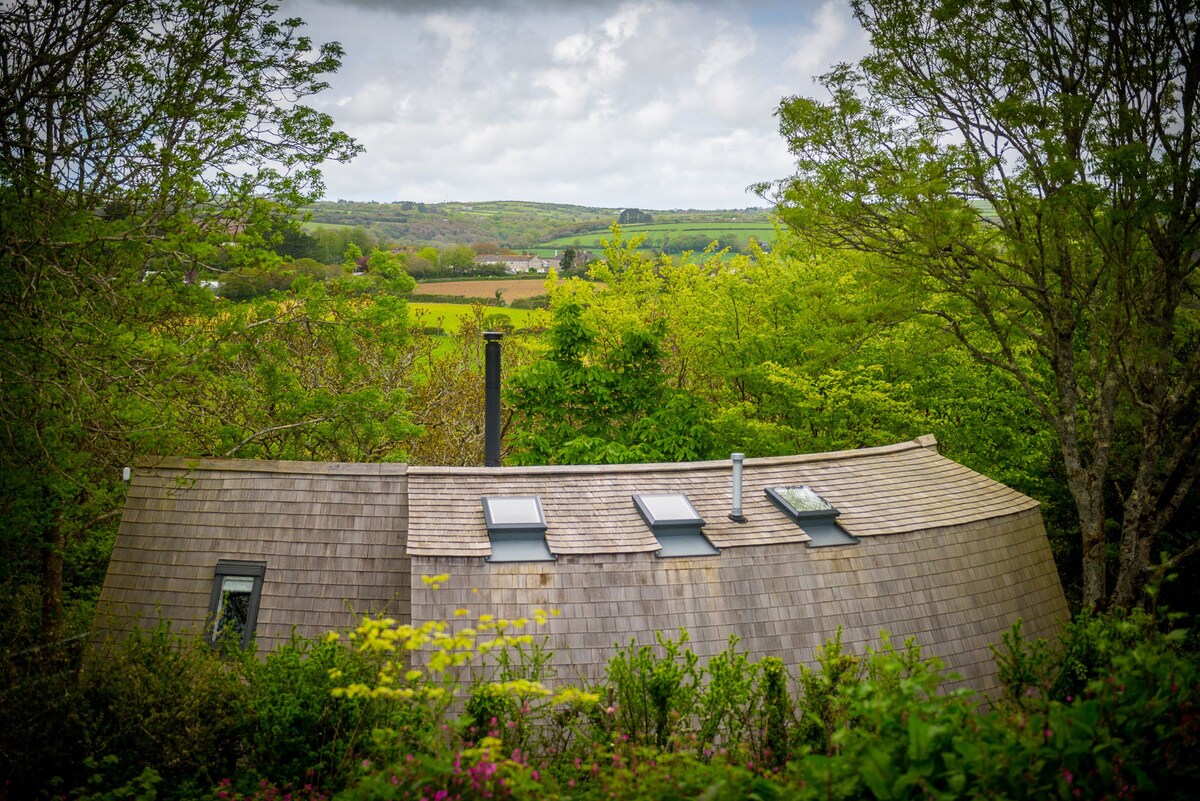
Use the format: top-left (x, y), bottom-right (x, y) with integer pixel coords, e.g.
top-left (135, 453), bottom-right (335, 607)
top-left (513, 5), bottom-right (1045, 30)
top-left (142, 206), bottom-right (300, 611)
top-left (282, 0), bottom-right (866, 209)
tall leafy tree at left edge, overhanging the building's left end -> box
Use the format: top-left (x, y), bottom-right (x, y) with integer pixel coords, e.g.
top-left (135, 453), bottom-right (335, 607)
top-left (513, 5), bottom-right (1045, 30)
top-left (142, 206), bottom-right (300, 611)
top-left (0, 0), bottom-right (359, 638)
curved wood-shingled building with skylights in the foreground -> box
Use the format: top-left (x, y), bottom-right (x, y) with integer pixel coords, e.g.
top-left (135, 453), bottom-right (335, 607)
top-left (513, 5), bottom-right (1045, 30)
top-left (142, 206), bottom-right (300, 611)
top-left (95, 436), bottom-right (1068, 691)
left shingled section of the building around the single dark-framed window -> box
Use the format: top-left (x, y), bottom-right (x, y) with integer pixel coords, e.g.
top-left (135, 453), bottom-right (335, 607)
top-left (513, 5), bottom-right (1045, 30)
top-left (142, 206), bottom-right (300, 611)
top-left (95, 458), bottom-right (412, 652)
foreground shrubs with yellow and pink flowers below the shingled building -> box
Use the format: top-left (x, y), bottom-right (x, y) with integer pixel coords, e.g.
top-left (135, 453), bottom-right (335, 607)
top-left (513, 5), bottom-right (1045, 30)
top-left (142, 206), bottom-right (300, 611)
top-left (0, 577), bottom-right (1200, 801)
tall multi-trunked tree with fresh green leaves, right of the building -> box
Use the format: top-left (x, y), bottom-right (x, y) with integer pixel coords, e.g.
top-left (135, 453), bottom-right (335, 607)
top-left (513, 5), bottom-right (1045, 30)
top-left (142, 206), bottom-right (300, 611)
top-left (760, 0), bottom-right (1200, 606)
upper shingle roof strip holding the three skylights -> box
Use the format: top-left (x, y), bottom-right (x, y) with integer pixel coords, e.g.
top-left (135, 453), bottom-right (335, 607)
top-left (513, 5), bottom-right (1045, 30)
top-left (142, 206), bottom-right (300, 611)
top-left (408, 436), bottom-right (1037, 556)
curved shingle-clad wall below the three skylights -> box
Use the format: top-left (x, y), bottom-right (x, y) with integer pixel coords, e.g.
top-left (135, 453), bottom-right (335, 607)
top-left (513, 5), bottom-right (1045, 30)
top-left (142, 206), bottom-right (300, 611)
top-left (412, 508), bottom-right (1068, 692)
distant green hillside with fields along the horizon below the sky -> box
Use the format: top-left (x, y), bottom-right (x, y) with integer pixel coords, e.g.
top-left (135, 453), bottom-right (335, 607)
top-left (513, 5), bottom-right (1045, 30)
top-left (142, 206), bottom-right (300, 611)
top-left (298, 200), bottom-right (772, 249)
